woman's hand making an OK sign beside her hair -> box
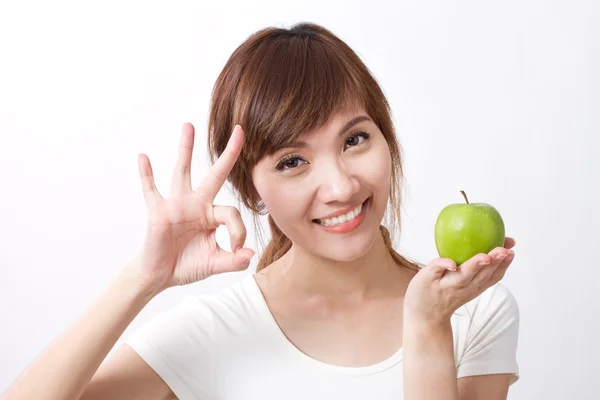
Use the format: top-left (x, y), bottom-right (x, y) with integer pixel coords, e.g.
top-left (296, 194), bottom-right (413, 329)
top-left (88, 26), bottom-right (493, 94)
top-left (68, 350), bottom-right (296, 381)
top-left (133, 123), bottom-right (254, 292)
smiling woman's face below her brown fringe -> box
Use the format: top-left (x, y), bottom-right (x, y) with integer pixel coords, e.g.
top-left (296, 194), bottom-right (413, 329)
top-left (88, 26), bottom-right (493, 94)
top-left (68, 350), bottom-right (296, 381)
top-left (252, 109), bottom-right (391, 261)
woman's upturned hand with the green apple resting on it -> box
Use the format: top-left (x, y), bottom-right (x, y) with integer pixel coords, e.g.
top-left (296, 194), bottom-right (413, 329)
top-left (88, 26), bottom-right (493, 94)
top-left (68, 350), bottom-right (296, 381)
top-left (404, 237), bottom-right (515, 323)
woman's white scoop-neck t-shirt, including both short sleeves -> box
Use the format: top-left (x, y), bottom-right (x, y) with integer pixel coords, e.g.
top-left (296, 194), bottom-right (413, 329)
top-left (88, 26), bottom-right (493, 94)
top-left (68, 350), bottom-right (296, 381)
top-left (125, 274), bottom-right (519, 400)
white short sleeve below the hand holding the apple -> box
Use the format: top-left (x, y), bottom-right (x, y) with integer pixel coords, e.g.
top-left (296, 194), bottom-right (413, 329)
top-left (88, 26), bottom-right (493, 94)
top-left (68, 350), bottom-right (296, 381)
top-left (457, 283), bottom-right (519, 385)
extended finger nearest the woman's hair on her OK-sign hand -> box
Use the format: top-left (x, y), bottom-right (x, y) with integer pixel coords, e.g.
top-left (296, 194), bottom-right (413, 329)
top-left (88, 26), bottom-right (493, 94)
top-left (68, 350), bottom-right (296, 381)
top-left (198, 125), bottom-right (244, 202)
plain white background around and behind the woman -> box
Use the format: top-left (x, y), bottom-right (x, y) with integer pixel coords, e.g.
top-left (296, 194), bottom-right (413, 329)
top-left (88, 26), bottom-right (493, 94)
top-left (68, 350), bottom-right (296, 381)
top-left (0, 0), bottom-right (600, 400)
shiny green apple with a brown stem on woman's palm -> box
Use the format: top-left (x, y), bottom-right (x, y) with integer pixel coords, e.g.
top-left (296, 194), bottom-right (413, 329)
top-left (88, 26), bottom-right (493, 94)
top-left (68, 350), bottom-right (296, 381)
top-left (435, 190), bottom-right (504, 266)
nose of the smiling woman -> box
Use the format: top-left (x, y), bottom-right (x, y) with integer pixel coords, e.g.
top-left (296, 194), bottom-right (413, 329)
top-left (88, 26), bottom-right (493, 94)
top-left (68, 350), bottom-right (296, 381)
top-left (315, 160), bottom-right (360, 203)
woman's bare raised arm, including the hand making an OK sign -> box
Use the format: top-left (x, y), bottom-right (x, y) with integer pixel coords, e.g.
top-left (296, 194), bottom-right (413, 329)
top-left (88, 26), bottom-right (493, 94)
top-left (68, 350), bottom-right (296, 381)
top-left (4, 124), bottom-right (254, 400)
